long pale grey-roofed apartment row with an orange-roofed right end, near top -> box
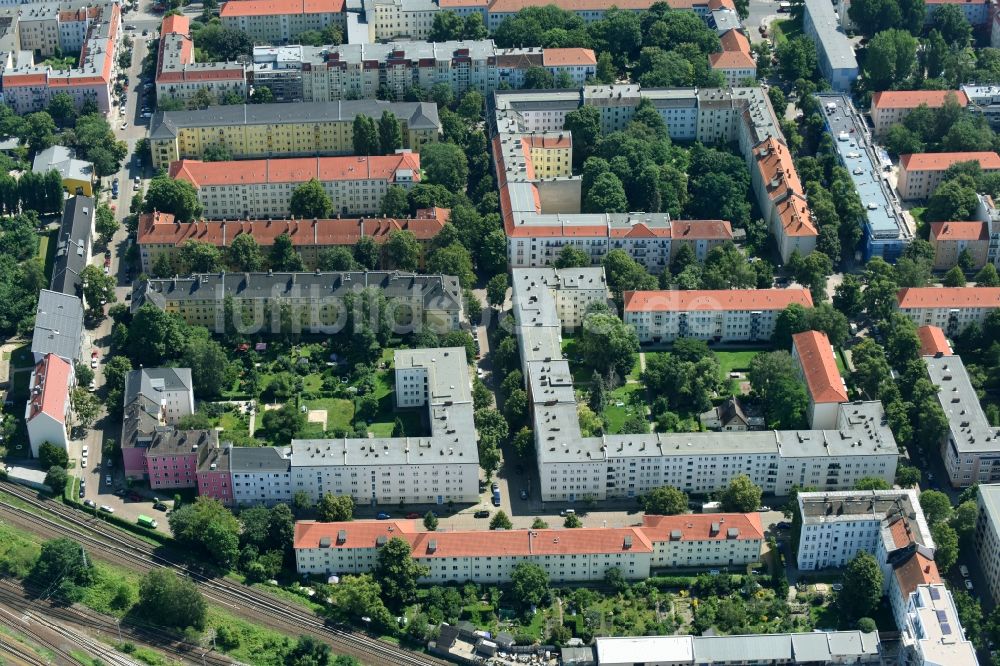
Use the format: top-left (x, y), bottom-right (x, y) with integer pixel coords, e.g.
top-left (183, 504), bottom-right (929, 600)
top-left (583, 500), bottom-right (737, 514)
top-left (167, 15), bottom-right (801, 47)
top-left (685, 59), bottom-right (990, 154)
top-left (252, 39), bottom-right (597, 102)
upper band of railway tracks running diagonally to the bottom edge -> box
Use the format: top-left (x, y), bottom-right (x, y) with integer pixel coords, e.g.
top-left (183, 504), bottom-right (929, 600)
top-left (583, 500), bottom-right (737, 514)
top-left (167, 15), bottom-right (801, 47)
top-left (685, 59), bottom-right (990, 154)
top-left (0, 482), bottom-right (448, 666)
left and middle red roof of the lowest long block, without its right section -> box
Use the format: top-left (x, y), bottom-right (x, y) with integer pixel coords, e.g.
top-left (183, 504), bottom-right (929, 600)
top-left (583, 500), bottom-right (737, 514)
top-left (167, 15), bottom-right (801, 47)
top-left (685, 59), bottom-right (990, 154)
top-left (294, 520), bottom-right (653, 558)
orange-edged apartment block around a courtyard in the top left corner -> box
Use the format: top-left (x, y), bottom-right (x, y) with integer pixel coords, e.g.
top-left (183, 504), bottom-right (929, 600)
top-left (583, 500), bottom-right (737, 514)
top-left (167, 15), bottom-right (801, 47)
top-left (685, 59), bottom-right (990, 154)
top-left (0, 2), bottom-right (122, 113)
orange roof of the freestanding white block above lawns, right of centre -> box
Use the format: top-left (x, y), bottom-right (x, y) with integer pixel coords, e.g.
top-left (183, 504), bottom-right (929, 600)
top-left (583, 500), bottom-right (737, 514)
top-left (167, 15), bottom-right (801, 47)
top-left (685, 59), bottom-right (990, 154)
top-left (623, 289), bottom-right (812, 312)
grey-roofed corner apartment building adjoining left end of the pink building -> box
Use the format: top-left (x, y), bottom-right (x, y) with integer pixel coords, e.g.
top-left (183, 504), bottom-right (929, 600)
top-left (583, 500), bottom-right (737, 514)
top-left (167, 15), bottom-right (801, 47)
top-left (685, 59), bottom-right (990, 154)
top-left (121, 368), bottom-right (196, 482)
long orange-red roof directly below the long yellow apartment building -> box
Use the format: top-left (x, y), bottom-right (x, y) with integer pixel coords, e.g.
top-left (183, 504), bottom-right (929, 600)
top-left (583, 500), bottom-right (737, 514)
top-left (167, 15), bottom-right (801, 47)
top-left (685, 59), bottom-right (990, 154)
top-left (170, 153), bottom-right (420, 188)
